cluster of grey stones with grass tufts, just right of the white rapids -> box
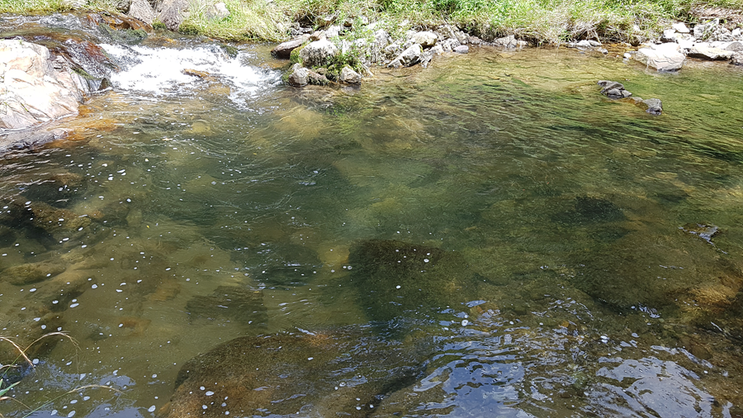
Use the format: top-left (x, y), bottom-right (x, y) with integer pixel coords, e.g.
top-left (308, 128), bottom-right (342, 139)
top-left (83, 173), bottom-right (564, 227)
top-left (271, 16), bottom-right (528, 86)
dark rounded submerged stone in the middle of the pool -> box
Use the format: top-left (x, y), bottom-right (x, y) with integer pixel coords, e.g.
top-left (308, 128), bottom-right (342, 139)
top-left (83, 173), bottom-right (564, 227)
top-left (349, 240), bottom-right (474, 321)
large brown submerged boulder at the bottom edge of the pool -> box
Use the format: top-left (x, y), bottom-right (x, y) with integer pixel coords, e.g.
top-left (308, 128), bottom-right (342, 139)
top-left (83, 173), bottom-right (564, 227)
top-left (158, 330), bottom-right (430, 418)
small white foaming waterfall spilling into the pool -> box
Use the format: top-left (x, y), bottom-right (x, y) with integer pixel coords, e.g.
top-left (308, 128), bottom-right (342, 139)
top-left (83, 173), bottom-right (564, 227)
top-left (101, 44), bottom-right (281, 105)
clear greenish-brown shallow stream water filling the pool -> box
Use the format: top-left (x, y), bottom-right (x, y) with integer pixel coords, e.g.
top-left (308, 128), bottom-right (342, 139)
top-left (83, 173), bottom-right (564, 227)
top-left (0, 46), bottom-right (743, 417)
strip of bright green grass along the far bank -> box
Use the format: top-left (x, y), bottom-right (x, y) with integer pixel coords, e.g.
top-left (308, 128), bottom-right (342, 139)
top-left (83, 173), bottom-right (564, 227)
top-left (0, 0), bottom-right (743, 43)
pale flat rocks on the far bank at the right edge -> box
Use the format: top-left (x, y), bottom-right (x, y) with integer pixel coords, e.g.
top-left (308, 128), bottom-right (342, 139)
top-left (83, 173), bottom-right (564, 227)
top-left (625, 20), bottom-right (743, 71)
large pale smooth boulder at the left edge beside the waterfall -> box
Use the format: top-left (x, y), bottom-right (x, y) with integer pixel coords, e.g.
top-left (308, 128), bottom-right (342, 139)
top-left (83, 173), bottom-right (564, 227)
top-left (0, 40), bottom-right (90, 129)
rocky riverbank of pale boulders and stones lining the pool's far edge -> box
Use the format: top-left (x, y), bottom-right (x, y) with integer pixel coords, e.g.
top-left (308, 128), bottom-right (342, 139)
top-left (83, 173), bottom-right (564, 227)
top-left (0, 4), bottom-right (743, 146)
